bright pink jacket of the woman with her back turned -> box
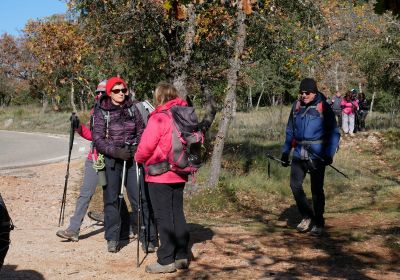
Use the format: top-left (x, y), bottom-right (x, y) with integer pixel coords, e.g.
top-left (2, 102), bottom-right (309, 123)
top-left (135, 98), bottom-right (188, 183)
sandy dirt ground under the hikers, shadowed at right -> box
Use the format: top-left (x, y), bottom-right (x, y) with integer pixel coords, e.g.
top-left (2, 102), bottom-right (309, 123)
top-left (0, 137), bottom-right (400, 280)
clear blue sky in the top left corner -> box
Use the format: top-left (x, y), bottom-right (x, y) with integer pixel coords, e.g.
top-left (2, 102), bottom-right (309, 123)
top-left (0, 0), bottom-right (67, 36)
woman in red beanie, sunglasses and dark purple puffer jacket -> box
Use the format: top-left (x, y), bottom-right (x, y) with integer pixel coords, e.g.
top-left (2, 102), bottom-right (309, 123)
top-left (93, 77), bottom-right (157, 253)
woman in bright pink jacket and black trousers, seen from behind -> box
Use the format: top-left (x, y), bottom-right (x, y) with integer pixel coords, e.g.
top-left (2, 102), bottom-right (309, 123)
top-left (135, 82), bottom-right (189, 273)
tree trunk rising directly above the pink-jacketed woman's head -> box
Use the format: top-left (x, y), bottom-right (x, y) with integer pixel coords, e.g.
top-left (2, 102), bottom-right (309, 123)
top-left (173, 4), bottom-right (196, 99)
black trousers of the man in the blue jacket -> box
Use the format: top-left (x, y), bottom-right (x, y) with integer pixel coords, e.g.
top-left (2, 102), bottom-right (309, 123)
top-left (290, 158), bottom-right (325, 226)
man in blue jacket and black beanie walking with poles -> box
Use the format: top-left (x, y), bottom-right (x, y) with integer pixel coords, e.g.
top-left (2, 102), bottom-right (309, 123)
top-left (281, 78), bottom-right (340, 235)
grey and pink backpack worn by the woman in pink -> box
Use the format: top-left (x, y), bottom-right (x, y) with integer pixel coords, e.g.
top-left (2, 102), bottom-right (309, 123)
top-left (148, 105), bottom-right (204, 175)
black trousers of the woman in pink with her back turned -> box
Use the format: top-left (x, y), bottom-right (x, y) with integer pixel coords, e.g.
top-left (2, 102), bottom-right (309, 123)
top-left (149, 183), bottom-right (189, 265)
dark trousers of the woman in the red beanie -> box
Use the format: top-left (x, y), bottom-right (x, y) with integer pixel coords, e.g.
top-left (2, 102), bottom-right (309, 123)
top-left (103, 157), bottom-right (157, 243)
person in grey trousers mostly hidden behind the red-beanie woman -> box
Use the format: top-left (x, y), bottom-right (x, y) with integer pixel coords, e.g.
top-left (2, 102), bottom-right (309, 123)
top-left (56, 80), bottom-right (107, 242)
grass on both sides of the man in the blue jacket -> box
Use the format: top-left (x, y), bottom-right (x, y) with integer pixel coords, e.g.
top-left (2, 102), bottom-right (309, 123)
top-left (186, 108), bottom-right (400, 238)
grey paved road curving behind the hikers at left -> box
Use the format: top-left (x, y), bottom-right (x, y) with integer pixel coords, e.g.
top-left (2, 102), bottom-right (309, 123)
top-left (0, 130), bottom-right (90, 170)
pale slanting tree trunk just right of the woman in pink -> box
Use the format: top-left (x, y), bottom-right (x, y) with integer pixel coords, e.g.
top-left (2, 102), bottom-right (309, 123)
top-left (207, 1), bottom-right (246, 187)
